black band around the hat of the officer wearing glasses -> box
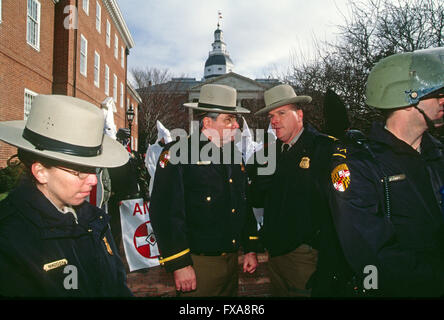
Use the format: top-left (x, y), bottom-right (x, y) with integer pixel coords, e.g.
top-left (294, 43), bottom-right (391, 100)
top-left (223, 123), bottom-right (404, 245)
top-left (22, 127), bottom-right (102, 157)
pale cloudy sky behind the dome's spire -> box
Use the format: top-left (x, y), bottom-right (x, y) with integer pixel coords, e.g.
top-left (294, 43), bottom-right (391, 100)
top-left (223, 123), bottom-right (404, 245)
top-left (118, 0), bottom-right (354, 80)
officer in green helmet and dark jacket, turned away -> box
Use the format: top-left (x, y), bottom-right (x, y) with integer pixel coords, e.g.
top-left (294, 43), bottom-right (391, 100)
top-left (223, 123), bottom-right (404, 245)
top-left (330, 48), bottom-right (444, 297)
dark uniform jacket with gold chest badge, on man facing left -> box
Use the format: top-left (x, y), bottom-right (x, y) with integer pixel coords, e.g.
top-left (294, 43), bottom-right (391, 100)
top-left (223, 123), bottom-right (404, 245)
top-left (251, 124), bottom-right (333, 256)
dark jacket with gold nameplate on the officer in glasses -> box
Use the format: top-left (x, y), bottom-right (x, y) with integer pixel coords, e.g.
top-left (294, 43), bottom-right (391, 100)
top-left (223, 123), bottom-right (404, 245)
top-left (0, 181), bottom-right (131, 297)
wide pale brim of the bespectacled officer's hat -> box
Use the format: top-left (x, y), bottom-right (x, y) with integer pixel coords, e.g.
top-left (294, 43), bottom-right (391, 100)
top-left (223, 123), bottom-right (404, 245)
top-left (0, 120), bottom-right (129, 168)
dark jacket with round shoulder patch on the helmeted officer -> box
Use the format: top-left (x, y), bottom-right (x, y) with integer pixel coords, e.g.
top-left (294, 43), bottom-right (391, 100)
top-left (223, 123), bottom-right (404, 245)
top-left (329, 124), bottom-right (444, 296)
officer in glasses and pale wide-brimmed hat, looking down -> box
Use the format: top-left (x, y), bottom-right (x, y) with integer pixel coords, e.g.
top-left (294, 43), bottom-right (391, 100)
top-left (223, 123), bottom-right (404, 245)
top-left (0, 95), bottom-right (131, 297)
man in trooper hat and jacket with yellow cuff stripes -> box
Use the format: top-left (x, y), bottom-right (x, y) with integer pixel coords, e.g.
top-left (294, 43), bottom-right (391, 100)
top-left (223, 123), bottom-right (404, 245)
top-left (150, 84), bottom-right (258, 296)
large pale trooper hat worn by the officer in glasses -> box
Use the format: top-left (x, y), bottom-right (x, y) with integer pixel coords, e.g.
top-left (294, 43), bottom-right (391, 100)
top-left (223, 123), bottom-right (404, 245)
top-left (0, 95), bottom-right (129, 168)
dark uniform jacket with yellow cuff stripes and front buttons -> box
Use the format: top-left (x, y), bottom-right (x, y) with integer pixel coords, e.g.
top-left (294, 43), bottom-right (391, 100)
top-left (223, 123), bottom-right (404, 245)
top-left (150, 136), bottom-right (258, 272)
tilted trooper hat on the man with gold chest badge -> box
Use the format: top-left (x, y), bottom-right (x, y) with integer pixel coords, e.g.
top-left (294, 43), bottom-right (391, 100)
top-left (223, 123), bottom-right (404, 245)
top-left (255, 84), bottom-right (311, 115)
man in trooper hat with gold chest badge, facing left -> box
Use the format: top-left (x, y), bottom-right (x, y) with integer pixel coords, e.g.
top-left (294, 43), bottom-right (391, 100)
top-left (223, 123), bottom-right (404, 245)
top-left (251, 84), bottom-right (333, 297)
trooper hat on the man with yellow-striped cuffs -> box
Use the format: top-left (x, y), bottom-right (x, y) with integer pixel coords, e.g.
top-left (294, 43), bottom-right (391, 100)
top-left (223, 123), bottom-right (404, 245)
top-left (184, 84), bottom-right (250, 113)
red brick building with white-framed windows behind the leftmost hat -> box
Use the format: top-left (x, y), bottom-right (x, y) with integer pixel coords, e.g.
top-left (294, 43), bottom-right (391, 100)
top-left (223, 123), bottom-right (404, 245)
top-left (0, 0), bottom-right (141, 167)
